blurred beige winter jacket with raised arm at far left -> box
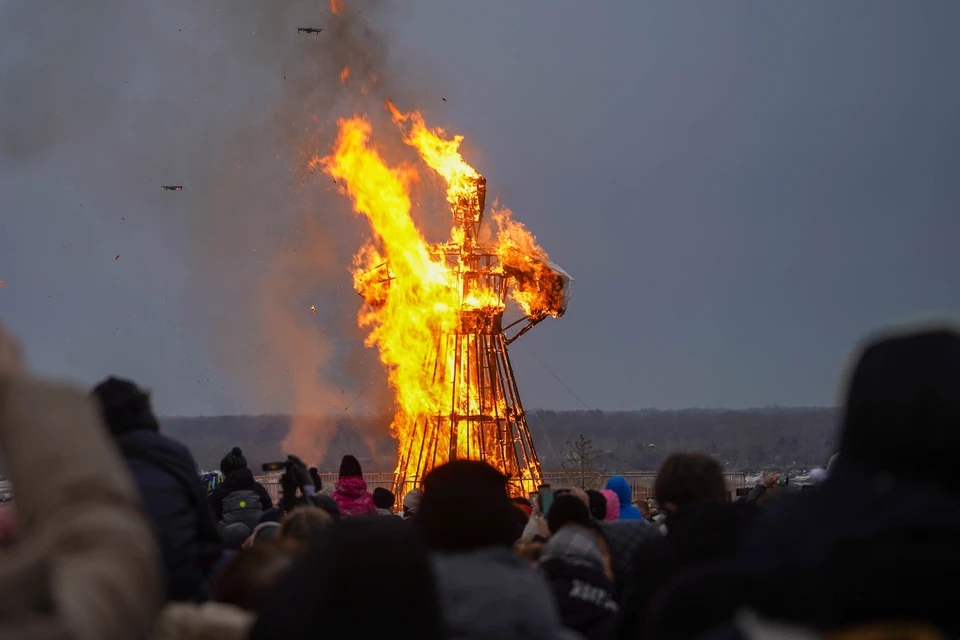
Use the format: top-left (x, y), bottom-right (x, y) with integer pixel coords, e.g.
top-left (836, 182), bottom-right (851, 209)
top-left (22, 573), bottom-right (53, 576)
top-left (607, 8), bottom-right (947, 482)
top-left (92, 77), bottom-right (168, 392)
top-left (0, 378), bottom-right (162, 640)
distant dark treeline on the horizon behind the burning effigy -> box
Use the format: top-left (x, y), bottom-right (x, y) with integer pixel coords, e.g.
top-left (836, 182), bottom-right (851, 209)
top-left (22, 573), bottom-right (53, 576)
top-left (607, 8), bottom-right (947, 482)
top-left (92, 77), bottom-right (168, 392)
top-left (162, 407), bottom-right (837, 473)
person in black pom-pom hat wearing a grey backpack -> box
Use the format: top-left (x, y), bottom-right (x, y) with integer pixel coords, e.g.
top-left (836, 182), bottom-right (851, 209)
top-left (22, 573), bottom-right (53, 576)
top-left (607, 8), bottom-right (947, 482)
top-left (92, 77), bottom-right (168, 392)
top-left (210, 447), bottom-right (273, 548)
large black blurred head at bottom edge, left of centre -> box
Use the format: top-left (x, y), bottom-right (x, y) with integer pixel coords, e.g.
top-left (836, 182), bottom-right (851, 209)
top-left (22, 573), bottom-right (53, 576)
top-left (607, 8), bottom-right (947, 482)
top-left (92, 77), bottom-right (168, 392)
top-left (250, 518), bottom-right (442, 640)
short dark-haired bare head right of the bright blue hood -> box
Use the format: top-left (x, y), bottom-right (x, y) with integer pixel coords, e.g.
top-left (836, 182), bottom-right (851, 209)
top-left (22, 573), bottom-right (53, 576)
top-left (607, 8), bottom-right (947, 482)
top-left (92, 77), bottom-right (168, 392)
top-left (653, 453), bottom-right (726, 512)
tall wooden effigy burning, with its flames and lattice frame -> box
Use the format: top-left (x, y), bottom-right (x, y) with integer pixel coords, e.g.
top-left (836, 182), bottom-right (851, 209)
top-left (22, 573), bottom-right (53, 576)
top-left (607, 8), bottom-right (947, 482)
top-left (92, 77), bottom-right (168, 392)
top-left (320, 105), bottom-right (571, 497)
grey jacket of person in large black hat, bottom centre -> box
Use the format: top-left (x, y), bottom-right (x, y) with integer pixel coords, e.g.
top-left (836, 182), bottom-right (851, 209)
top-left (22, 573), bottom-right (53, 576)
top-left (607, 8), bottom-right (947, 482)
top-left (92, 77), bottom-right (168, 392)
top-left (433, 547), bottom-right (580, 640)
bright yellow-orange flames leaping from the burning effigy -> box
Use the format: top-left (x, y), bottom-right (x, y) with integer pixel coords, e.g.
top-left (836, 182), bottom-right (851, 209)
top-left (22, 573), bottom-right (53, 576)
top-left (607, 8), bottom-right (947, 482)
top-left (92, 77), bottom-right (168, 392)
top-left (320, 103), bottom-right (562, 487)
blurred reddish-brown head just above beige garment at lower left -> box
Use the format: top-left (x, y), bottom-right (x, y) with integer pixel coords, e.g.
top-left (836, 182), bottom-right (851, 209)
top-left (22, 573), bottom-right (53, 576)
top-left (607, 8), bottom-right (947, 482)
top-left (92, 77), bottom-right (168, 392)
top-left (213, 540), bottom-right (296, 611)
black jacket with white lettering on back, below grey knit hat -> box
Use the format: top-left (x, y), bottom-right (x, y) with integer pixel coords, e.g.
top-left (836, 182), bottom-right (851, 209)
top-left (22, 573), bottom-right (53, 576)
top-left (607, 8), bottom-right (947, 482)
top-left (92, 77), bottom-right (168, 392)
top-left (540, 558), bottom-right (617, 640)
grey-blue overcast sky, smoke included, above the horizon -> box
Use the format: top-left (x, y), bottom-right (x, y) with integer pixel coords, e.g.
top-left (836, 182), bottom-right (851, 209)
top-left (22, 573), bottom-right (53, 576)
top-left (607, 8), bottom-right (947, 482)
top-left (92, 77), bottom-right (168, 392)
top-left (0, 0), bottom-right (960, 415)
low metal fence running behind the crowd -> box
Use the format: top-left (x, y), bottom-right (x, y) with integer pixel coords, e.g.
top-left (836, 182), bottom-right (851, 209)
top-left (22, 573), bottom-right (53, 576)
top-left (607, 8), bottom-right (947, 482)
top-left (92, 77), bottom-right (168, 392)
top-left (257, 471), bottom-right (747, 502)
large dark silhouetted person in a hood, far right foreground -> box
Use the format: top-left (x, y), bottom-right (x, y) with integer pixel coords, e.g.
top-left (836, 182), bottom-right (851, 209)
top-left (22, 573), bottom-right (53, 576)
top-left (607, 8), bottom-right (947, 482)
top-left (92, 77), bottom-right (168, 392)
top-left (724, 327), bottom-right (960, 637)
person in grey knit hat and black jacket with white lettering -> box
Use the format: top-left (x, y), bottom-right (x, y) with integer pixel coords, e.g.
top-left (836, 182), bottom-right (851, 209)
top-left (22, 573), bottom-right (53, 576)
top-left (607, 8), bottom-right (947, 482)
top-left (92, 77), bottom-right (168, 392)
top-left (540, 525), bottom-right (617, 640)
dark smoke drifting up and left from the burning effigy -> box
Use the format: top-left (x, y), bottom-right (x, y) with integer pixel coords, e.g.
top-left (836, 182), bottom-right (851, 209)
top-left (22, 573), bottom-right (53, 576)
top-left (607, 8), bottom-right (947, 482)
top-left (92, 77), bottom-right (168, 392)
top-left (0, 0), bottom-right (424, 457)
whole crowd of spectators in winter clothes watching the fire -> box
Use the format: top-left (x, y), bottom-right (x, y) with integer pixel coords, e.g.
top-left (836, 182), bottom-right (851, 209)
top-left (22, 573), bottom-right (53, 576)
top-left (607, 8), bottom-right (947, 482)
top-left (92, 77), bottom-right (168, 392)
top-left (0, 327), bottom-right (960, 640)
